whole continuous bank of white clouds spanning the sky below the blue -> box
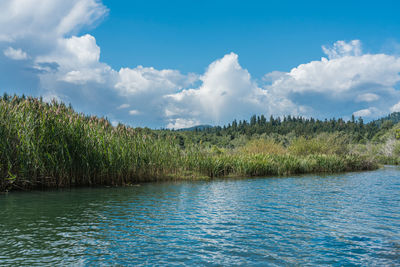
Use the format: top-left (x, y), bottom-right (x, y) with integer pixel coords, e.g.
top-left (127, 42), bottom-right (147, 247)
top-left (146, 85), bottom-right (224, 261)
top-left (0, 0), bottom-right (400, 129)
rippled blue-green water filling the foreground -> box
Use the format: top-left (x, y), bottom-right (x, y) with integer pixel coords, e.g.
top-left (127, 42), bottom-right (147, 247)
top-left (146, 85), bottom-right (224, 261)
top-left (0, 167), bottom-right (400, 266)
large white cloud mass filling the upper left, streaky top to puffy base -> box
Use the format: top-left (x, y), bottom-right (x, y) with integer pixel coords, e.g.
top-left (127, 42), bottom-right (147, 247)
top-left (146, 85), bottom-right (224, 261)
top-left (0, 0), bottom-right (113, 110)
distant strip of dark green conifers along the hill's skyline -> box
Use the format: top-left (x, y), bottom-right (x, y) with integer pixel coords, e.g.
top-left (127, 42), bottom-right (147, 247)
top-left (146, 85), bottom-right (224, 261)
top-left (177, 112), bottom-right (400, 146)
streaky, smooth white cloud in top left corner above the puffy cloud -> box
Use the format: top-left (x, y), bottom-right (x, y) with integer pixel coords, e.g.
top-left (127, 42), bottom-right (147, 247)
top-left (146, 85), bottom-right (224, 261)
top-left (0, 0), bottom-right (108, 42)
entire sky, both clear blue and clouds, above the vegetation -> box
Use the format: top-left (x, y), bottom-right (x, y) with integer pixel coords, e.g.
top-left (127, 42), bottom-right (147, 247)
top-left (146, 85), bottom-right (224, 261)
top-left (0, 0), bottom-right (400, 129)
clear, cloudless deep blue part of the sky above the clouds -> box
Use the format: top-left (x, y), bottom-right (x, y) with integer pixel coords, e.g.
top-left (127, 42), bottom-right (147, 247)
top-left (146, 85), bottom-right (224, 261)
top-left (91, 1), bottom-right (400, 77)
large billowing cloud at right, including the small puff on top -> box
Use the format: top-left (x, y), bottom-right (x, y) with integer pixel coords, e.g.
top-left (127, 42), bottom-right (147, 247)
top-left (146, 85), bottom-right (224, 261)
top-left (264, 40), bottom-right (400, 117)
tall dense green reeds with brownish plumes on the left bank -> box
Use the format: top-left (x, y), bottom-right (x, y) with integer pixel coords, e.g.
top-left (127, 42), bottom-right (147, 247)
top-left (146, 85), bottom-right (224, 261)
top-left (0, 96), bottom-right (189, 192)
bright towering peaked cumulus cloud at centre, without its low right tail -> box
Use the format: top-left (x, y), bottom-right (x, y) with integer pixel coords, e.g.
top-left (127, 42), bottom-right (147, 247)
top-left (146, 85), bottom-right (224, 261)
top-left (165, 53), bottom-right (268, 127)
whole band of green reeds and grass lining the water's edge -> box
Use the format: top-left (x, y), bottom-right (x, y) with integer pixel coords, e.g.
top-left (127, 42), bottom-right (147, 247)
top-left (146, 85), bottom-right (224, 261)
top-left (0, 96), bottom-right (377, 191)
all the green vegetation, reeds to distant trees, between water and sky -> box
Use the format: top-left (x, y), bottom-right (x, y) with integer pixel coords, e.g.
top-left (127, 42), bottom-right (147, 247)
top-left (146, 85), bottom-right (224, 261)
top-left (0, 94), bottom-right (400, 191)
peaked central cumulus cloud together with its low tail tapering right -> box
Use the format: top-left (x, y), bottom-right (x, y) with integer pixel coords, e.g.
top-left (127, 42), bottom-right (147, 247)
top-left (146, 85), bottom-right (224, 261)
top-left (165, 53), bottom-right (308, 128)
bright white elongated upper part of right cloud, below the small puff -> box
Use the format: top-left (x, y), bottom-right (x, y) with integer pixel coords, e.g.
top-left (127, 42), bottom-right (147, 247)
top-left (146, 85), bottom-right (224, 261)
top-left (270, 54), bottom-right (400, 97)
